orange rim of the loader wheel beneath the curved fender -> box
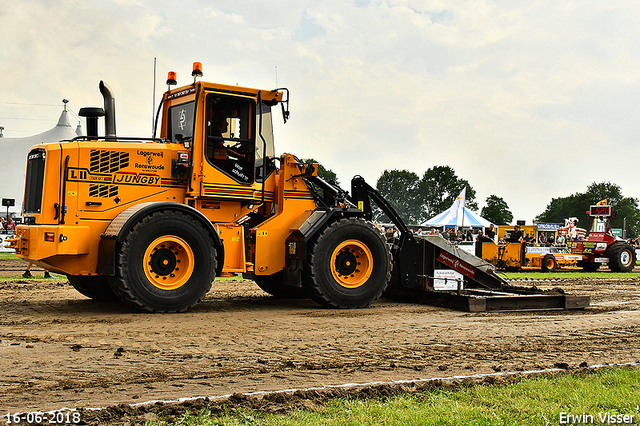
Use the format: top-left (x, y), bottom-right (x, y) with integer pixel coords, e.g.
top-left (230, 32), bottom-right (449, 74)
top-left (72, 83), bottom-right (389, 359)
top-left (144, 235), bottom-right (194, 290)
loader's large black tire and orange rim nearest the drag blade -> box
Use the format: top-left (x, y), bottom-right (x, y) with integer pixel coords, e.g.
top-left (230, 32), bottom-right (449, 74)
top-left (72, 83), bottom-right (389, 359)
top-left (303, 218), bottom-right (391, 308)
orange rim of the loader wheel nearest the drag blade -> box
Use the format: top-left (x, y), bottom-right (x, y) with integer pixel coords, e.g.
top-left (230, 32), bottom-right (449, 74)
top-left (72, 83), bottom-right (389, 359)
top-left (331, 240), bottom-right (373, 288)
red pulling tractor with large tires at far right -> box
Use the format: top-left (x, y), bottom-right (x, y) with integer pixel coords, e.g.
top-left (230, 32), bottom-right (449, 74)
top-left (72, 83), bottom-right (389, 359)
top-left (567, 204), bottom-right (636, 272)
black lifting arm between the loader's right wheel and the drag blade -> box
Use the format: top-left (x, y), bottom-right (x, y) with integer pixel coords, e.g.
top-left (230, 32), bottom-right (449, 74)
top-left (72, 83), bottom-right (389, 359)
top-left (351, 176), bottom-right (421, 288)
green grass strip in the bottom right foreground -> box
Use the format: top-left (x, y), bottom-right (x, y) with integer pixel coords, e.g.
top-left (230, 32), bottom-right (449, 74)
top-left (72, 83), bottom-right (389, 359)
top-left (146, 369), bottom-right (640, 426)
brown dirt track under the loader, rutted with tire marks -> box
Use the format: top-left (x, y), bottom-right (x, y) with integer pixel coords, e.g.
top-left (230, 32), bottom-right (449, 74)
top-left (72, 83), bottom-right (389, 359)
top-left (0, 261), bottom-right (640, 424)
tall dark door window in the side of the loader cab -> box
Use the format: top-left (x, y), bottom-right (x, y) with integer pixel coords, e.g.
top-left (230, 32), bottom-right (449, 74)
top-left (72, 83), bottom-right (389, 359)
top-left (205, 93), bottom-right (255, 183)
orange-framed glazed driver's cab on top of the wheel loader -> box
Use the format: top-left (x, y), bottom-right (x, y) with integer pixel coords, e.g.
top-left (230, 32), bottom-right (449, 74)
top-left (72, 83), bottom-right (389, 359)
top-left (161, 73), bottom-right (288, 201)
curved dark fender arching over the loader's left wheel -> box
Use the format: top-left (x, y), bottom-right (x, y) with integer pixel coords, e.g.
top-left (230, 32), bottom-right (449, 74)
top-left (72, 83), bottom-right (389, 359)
top-left (96, 201), bottom-right (224, 276)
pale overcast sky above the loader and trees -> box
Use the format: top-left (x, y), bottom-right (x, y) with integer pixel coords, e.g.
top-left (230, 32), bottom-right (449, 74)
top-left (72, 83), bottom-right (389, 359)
top-left (0, 0), bottom-right (640, 223)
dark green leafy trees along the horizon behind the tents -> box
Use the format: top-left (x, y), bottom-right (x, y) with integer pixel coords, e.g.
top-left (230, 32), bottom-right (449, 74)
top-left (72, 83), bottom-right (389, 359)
top-left (304, 159), bottom-right (640, 237)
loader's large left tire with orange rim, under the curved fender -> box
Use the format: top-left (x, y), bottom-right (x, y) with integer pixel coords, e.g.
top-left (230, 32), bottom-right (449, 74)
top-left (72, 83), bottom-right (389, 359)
top-left (111, 211), bottom-right (216, 312)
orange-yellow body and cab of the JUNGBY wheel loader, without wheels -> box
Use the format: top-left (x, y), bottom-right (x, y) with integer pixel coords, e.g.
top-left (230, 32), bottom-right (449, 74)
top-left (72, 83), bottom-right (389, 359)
top-left (14, 82), bottom-right (317, 275)
